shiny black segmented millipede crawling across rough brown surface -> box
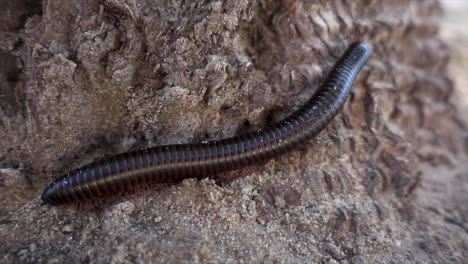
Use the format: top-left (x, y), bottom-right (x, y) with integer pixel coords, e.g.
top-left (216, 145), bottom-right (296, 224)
top-left (42, 42), bottom-right (371, 205)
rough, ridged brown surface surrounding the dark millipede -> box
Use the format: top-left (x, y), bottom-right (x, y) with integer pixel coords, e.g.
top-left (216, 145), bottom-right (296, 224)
top-left (0, 0), bottom-right (468, 263)
